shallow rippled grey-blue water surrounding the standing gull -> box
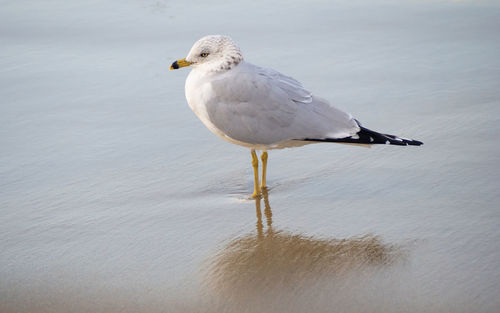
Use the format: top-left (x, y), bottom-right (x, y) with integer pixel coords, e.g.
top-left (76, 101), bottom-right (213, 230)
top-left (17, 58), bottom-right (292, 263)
top-left (0, 0), bottom-right (500, 312)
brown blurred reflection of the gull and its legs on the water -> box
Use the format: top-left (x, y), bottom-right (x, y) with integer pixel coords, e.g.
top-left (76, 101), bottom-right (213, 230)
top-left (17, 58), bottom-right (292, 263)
top-left (207, 190), bottom-right (400, 296)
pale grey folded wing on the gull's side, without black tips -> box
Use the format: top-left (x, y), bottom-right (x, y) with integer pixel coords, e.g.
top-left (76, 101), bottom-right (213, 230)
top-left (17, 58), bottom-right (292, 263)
top-left (206, 63), bottom-right (359, 145)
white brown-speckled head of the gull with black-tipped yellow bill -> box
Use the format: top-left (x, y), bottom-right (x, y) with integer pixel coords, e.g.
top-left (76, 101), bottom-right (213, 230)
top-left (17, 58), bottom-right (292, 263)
top-left (170, 35), bottom-right (243, 72)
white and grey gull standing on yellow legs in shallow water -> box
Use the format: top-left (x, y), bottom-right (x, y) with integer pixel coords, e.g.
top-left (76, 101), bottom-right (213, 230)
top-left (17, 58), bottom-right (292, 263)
top-left (170, 35), bottom-right (422, 198)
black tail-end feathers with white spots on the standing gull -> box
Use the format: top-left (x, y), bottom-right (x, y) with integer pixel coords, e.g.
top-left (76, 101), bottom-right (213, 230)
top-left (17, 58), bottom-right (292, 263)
top-left (303, 121), bottom-right (423, 146)
